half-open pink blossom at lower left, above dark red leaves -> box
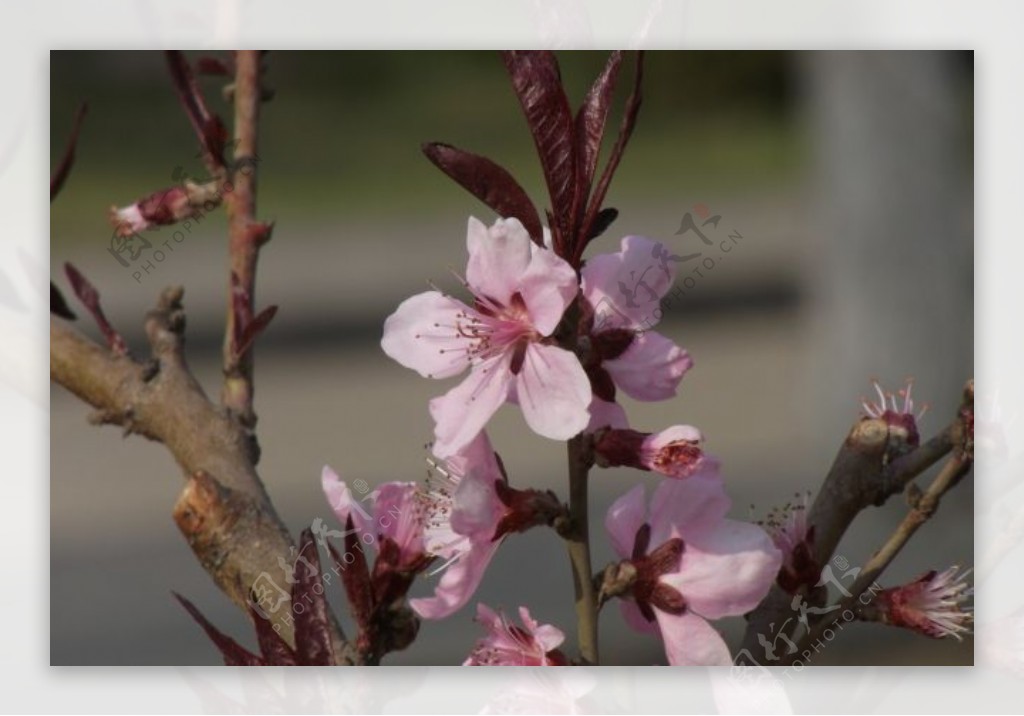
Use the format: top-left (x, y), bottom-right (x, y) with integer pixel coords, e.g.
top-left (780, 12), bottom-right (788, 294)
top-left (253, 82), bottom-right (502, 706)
top-left (321, 465), bottom-right (427, 568)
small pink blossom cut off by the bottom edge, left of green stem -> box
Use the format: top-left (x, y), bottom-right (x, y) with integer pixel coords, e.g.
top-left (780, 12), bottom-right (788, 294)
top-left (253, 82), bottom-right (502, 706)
top-left (463, 604), bottom-right (568, 666)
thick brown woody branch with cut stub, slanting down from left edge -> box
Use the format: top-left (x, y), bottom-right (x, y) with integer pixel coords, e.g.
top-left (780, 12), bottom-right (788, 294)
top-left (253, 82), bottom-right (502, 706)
top-left (50, 288), bottom-right (356, 662)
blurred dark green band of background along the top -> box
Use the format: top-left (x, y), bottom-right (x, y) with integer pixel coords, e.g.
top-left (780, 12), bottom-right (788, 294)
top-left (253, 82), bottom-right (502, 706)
top-left (50, 51), bottom-right (802, 242)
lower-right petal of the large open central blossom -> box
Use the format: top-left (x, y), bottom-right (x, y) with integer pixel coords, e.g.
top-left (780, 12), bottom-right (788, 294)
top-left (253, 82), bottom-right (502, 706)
top-left (515, 343), bottom-right (591, 440)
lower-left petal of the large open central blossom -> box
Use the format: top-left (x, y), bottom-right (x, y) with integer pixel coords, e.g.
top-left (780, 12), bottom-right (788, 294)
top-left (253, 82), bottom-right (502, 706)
top-left (430, 353), bottom-right (512, 459)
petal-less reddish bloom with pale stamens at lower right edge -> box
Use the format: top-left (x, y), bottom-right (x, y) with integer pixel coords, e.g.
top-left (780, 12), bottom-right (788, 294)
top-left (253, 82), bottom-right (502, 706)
top-left (876, 566), bottom-right (974, 639)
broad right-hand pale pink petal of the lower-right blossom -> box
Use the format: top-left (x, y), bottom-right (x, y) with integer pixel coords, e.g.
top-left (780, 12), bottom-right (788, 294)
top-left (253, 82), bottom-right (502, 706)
top-left (662, 519), bottom-right (782, 619)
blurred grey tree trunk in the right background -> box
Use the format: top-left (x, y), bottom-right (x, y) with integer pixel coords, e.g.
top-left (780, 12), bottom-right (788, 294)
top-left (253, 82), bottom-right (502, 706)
top-left (797, 51), bottom-right (974, 457)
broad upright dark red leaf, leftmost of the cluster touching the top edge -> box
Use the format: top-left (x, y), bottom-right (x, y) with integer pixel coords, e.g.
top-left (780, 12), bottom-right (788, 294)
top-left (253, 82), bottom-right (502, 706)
top-left (503, 51), bottom-right (578, 243)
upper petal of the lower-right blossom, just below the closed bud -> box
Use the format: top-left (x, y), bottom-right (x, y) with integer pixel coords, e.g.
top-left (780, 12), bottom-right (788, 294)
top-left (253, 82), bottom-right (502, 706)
top-left (650, 471), bottom-right (731, 549)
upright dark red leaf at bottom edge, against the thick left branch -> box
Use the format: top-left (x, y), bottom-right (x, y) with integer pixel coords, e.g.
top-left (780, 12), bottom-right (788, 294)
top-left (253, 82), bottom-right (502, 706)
top-left (292, 529), bottom-right (334, 666)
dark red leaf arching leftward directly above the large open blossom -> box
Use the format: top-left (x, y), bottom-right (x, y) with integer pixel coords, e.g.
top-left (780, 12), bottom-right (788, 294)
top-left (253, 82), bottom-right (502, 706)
top-left (423, 141), bottom-right (544, 245)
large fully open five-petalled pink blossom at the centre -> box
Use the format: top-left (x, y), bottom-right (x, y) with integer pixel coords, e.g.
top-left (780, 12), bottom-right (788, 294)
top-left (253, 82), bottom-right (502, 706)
top-left (381, 218), bottom-right (591, 458)
